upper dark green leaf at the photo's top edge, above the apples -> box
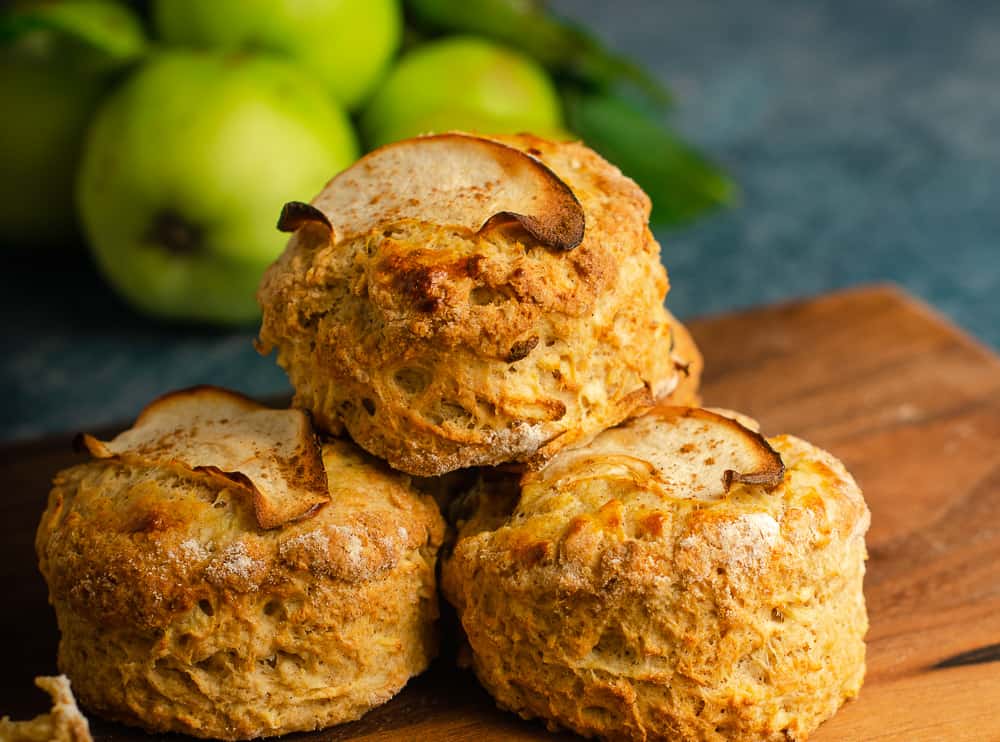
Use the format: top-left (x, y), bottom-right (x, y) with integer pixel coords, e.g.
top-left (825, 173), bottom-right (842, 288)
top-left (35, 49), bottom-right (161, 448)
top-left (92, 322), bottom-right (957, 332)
top-left (406, 0), bottom-right (670, 107)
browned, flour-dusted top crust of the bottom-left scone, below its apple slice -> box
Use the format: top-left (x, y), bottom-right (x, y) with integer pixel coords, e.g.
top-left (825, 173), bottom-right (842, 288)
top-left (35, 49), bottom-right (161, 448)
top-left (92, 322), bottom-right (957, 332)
top-left (37, 402), bottom-right (444, 628)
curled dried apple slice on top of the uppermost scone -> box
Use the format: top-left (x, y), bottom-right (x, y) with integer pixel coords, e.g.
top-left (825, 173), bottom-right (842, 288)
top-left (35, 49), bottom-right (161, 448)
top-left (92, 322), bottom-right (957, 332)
top-left (279, 133), bottom-right (585, 250)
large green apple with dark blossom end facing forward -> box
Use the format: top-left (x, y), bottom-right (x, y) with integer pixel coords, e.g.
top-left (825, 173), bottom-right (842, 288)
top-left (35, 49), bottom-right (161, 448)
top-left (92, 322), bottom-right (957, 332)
top-left (77, 51), bottom-right (357, 324)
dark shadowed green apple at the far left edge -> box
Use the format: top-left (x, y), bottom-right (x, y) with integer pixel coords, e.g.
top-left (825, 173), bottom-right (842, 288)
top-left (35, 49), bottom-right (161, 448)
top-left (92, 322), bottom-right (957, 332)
top-left (0, 0), bottom-right (146, 248)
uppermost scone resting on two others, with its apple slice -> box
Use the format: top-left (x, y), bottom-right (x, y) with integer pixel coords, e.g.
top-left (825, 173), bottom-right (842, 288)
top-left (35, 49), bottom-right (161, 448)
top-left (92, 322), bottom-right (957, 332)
top-left (258, 133), bottom-right (697, 476)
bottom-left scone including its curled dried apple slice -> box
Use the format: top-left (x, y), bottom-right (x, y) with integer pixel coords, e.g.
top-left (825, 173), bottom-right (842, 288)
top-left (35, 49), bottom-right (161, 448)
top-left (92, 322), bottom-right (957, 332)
top-left (36, 388), bottom-right (443, 739)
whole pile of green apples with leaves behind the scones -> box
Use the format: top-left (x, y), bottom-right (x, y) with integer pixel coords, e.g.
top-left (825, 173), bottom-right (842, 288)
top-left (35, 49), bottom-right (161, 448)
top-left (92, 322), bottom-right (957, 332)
top-left (0, 0), bottom-right (733, 324)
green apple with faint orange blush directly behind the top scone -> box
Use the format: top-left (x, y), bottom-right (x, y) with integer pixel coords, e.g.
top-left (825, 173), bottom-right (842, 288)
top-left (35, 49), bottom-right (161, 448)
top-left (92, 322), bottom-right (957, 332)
top-left (361, 36), bottom-right (564, 147)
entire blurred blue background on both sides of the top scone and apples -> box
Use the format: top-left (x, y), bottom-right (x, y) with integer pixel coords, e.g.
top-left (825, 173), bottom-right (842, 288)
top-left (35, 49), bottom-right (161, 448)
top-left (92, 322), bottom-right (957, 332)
top-left (0, 0), bottom-right (1000, 439)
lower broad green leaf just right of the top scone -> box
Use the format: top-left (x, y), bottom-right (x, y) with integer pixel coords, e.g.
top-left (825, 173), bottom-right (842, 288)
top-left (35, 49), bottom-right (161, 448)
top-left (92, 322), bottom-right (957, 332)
top-left (563, 88), bottom-right (737, 225)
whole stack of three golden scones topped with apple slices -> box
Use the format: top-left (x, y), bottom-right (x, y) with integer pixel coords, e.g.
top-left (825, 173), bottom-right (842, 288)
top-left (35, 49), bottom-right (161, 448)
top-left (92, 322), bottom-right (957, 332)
top-left (37, 133), bottom-right (869, 740)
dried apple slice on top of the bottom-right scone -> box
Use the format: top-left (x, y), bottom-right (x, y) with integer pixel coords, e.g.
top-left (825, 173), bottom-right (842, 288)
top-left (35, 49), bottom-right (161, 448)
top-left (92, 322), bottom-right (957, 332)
top-left (525, 406), bottom-right (785, 499)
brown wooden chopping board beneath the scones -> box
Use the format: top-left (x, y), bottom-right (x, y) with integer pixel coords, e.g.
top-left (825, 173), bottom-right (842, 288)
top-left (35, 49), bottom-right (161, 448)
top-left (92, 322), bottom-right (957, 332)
top-left (0, 287), bottom-right (1000, 742)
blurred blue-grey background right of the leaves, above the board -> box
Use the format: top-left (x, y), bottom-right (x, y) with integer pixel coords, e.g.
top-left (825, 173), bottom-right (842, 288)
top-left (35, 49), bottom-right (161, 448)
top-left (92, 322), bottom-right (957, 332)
top-left (558, 0), bottom-right (1000, 328)
